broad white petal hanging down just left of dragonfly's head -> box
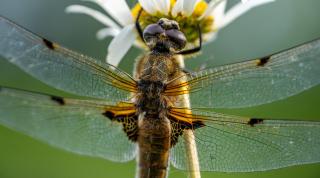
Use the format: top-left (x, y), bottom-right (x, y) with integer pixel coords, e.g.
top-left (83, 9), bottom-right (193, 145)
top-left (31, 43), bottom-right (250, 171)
top-left (106, 24), bottom-right (136, 66)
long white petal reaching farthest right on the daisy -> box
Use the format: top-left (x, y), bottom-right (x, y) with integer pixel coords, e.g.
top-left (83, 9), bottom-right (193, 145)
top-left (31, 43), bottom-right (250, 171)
top-left (217, 0), bottom-right (275, 28)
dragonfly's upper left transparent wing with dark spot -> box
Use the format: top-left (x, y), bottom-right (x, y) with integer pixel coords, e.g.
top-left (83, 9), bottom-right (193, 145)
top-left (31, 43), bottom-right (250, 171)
top-left (0, 17), bottom-right (136, 101)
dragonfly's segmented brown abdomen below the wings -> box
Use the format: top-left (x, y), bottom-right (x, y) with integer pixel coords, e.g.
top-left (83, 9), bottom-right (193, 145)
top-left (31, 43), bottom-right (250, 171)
top-left (137, 114), bottom-right (171, 178)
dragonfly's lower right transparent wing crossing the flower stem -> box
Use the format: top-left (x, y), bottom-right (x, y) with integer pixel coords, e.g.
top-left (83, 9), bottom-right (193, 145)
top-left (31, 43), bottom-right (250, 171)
top-left (170, 111), bottom-right (320, 172)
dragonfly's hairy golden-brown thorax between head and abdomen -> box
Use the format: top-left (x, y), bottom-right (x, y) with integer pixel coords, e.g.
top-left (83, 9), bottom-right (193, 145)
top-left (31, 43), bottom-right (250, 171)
top-left (135, 52), bottom-right (181, 118)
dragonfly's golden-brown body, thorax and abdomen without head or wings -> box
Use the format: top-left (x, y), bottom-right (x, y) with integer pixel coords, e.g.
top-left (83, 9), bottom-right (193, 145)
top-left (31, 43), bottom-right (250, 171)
top-left (135, 53), bottom-right (182, 178)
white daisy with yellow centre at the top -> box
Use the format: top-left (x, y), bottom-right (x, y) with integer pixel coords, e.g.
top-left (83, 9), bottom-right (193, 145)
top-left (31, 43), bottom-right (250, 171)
top-left (66, 0), bottom-right (275, 66)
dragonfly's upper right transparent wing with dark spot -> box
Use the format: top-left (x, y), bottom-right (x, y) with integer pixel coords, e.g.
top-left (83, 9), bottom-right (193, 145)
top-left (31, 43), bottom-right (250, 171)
top-left (166, 40), bottom-right (320, 108)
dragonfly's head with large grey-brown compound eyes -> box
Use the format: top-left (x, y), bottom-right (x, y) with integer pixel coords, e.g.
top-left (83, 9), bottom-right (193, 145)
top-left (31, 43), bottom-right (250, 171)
top-left (143, 18), bottom-right (187, 53)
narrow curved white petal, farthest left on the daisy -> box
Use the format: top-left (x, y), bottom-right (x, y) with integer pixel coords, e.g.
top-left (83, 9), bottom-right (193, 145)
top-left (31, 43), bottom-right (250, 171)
top-left (65, 5), bottom-right (120, 29)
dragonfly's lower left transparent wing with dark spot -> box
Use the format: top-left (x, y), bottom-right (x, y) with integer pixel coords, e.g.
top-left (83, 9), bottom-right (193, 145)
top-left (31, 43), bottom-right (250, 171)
top-left (0, 88), bottom-right (136, 162)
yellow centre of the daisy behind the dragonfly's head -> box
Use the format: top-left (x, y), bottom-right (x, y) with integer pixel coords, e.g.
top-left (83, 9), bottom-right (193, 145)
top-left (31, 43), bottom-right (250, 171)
top-left (131, 0), bottom-right (216, 46)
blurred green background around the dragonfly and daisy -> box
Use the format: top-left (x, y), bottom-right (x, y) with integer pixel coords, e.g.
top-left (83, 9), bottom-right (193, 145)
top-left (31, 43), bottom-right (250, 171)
top-left (0, 0), bottom-right (320, 178)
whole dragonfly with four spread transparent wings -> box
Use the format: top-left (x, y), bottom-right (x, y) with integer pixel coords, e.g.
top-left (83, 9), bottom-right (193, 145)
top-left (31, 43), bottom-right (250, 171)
top-left (0, 9), bottom-right (320, 177)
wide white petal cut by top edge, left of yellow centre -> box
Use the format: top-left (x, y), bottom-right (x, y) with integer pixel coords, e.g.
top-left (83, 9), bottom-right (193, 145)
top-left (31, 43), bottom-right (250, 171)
top-left (84, 0), bottom-right (134, 26)
